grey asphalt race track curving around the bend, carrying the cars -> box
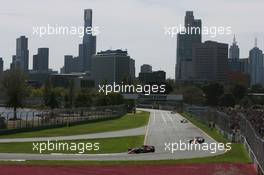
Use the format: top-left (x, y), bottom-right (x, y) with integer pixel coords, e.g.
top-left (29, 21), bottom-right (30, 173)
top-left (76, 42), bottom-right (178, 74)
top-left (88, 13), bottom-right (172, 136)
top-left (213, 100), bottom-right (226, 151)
top-left (0, 109), bottom-right (224, 161)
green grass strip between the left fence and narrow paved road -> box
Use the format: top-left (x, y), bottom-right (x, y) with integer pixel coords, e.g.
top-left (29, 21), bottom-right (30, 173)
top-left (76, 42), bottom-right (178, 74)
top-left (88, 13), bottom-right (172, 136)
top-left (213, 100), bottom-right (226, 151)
top-left (0, 111), bottom-right (149, 138)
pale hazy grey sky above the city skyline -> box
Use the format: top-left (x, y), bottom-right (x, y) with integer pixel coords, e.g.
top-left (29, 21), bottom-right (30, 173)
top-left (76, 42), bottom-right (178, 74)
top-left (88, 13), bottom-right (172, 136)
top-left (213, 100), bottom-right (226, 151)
top-left (0, 0), bottom-right (264, 78)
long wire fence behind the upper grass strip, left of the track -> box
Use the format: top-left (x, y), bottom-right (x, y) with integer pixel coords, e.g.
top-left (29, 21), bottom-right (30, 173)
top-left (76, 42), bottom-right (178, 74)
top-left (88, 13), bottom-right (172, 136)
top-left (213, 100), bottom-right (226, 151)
top-left (0, 105), bottom-right (127, 134)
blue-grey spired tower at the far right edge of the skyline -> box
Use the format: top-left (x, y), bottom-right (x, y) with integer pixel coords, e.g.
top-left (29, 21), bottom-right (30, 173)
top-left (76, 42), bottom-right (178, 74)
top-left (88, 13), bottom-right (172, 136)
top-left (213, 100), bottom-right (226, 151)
top-left (249, 39), bottom-right (264, 85)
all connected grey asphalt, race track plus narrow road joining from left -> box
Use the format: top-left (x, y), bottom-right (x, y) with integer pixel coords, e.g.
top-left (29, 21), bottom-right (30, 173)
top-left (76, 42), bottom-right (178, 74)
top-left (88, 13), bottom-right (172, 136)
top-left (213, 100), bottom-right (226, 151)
top-left (0, 109), bottom-right (224, 161)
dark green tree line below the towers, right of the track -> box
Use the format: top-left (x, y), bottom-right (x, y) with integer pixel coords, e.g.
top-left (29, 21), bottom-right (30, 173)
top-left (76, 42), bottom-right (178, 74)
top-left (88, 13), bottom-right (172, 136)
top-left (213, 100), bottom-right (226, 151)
top-left (169, 81), bottom-right (264, 107)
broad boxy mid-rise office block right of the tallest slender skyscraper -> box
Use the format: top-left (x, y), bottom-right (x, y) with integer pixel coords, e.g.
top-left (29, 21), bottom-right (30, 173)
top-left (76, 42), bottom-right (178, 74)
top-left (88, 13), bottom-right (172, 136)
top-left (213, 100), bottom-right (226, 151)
top-left (91, 49), bottom-right (135, 87)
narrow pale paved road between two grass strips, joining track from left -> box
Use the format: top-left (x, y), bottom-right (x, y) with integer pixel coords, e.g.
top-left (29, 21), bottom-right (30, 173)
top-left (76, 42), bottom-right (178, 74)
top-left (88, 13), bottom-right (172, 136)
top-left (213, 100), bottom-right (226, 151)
top-left (0, 127), bottom-right (146, 143)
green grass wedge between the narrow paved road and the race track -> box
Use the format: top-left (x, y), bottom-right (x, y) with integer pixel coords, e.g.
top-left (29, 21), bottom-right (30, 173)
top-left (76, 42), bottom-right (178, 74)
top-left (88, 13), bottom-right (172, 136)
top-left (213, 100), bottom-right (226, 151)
top-left (0, 136), bottom-right (144, 154)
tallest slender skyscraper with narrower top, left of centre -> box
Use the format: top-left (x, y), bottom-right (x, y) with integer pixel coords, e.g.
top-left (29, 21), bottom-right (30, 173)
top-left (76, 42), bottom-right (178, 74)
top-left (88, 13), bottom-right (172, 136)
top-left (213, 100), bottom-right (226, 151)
top-left (79, 9), bottom-right (96, 72)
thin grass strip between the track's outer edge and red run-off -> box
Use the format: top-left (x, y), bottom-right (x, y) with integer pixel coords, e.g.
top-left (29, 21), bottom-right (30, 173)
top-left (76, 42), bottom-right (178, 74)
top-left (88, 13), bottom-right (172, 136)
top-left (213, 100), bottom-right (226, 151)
top-left (0, 144), bottom-right (251, 166)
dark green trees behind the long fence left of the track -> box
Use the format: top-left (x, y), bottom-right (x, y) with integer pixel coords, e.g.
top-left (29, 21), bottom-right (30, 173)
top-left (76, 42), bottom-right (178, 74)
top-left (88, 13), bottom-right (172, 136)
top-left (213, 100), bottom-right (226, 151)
top-left (0, 69), bottom-right (125, 119)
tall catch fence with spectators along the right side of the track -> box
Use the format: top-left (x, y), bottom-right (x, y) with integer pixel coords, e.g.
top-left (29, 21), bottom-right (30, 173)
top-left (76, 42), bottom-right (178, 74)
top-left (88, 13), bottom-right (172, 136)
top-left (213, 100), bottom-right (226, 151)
top-left (184, 105), bottom-right (264, 175)
